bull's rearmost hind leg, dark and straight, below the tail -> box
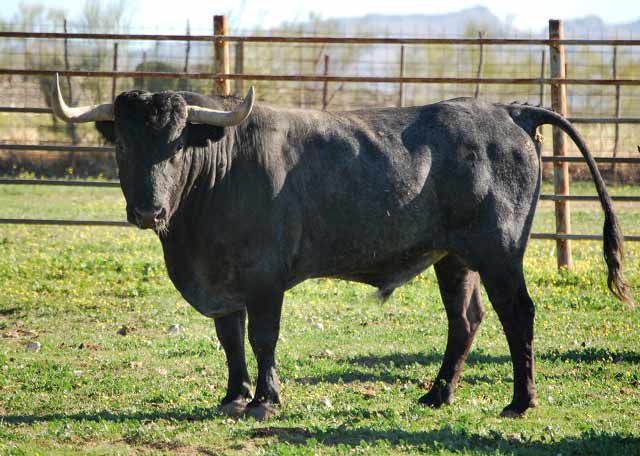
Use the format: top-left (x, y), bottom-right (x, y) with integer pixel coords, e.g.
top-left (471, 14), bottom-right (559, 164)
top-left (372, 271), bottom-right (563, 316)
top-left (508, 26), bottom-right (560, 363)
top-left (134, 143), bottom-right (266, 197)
top-left (480, 259), bottom-right (538, 417)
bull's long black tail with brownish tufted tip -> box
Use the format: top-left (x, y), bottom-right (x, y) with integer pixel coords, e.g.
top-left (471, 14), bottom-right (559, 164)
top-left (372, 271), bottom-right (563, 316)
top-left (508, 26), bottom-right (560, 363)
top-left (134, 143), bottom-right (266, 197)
top-left (506, 105), bottom-right (633, 307)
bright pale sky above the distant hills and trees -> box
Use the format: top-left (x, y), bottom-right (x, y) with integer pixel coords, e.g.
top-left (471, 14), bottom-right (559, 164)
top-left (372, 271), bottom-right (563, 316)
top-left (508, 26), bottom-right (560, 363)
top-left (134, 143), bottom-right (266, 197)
top-left (0, 0), bottom-right (640, 33)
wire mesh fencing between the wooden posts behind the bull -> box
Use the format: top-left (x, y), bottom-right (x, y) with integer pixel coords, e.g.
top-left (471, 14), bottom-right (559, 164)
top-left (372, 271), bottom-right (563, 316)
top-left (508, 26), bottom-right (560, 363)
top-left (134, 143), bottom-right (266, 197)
top-left (0, 18), bottom-right (640, 256)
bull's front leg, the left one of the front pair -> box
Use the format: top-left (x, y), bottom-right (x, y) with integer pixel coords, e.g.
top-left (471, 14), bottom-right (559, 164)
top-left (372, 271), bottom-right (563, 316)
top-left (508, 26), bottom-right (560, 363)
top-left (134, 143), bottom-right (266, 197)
top-left (215, 310), bottom-right (251, 416)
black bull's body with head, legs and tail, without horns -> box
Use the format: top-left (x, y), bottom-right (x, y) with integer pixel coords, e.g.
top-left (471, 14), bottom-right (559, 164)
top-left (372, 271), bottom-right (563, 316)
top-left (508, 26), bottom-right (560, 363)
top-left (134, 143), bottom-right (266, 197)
top-left (51, 84), bottom-right (631, 418)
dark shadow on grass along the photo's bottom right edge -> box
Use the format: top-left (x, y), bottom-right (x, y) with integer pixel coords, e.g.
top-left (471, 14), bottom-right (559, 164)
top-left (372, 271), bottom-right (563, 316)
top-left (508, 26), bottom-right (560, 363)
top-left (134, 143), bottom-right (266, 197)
top-left (250, 426), bottom-right (640, 455)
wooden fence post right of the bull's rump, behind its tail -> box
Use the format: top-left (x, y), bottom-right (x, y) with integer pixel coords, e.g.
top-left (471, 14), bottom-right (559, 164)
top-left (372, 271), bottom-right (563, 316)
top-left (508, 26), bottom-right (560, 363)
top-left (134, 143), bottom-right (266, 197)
top-left (549, 19), bottom-right (573, 269)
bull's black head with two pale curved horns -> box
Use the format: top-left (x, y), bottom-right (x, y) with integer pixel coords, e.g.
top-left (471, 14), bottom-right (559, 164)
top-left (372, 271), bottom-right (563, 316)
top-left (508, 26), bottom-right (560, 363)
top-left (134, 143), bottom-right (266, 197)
top-left (52, 75), bottom-right (253, 233)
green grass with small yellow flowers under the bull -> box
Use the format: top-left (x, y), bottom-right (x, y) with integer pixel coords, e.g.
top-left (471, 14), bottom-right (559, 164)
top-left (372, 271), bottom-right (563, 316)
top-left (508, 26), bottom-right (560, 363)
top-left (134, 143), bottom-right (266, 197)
top-left (0, 184), bottom-right (640, 455)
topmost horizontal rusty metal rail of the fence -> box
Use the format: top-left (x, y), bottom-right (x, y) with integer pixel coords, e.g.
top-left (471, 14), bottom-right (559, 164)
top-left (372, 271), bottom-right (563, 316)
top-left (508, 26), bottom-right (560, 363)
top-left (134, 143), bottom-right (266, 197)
top-left (0, 31), bottom-right (640, 46)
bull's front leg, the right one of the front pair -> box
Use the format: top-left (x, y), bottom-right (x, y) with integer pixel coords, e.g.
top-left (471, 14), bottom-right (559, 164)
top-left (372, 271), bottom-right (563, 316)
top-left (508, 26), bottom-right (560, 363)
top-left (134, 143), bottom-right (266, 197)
top-left (247, 290), bottom-right (284, 420)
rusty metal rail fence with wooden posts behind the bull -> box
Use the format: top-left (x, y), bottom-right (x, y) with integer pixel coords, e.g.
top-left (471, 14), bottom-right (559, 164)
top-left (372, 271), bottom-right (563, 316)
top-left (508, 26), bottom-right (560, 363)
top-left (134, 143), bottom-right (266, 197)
top-left (0, 18), bottom-right (640, 266)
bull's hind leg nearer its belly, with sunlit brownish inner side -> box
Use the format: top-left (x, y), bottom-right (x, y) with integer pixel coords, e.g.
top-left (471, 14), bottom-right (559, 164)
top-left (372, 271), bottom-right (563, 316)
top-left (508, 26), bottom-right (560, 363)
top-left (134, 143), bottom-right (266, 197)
top-left (420, 254), bottom-right (484, 407)
